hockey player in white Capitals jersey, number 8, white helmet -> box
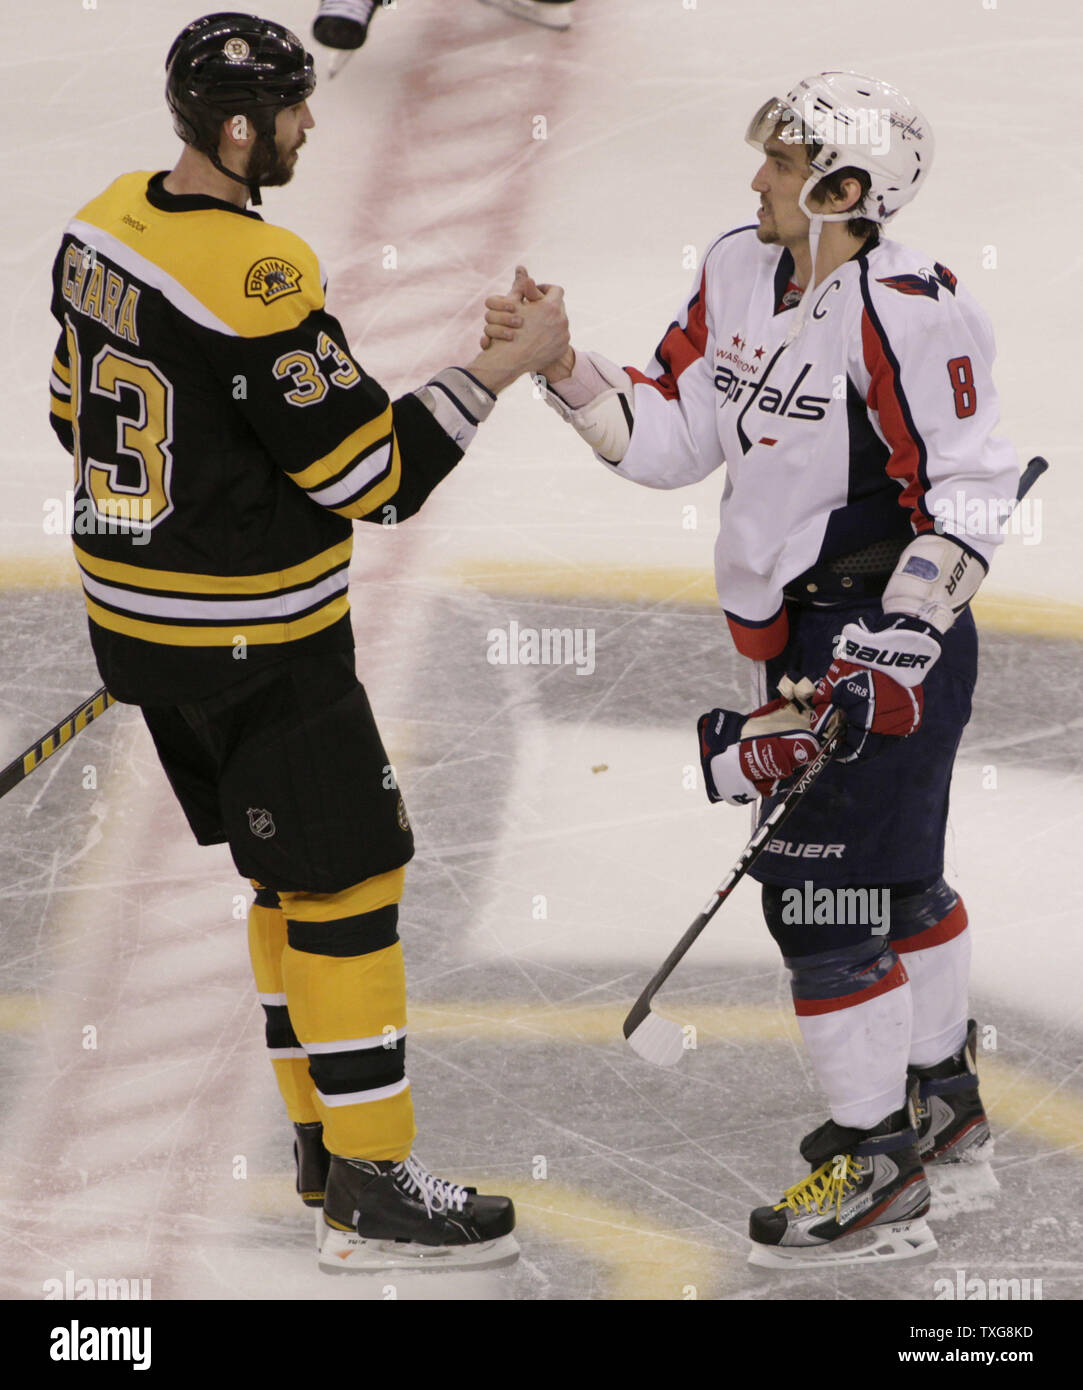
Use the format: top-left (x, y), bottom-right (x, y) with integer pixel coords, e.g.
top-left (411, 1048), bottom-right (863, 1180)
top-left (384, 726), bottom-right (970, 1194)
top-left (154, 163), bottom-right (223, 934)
top-left (482, 72), bottom-right (1018, 1266)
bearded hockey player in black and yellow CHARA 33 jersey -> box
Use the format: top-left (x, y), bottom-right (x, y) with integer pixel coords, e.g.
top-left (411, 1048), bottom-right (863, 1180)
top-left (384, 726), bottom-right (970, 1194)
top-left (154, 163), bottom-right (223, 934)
top-left (50, 13), bottom-right (569, 1270)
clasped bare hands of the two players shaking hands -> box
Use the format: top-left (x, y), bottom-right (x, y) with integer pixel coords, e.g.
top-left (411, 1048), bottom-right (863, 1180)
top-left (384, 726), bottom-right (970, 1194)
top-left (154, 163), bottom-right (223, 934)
top-left (467, 265), bottom-right (576, 393)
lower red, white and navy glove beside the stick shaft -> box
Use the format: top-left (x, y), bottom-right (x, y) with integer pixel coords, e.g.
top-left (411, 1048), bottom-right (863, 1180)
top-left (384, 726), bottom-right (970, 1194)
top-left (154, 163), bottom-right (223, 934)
top-left (698, 699), bottom-right (820, 806)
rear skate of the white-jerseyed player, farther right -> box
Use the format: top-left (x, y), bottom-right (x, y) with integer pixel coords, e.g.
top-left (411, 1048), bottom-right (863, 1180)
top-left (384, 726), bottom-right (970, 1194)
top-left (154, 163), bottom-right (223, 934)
top-left (909, 1019), bottom-right (1000, 1218)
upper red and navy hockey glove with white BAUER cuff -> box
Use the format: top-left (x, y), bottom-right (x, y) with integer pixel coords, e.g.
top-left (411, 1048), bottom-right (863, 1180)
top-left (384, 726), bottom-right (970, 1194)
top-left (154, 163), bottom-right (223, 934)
top-left (806, 613), bottom-right (940, 763)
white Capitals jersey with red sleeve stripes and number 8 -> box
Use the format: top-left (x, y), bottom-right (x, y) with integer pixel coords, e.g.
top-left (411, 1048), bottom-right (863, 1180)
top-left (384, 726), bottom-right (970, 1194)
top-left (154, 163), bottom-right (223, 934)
top-left (610, 227), bottom-right (1019, 660)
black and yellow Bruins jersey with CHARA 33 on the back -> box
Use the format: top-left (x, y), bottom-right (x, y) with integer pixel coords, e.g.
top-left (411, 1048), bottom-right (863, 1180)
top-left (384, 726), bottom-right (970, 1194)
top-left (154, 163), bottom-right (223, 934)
top-left (50, 172), bottom-right (462, 705)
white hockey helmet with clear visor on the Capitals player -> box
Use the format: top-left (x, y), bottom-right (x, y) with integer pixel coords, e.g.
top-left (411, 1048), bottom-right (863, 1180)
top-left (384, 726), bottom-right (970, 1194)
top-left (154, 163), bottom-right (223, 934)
top-left (745, 72), bottom-right (933, 225)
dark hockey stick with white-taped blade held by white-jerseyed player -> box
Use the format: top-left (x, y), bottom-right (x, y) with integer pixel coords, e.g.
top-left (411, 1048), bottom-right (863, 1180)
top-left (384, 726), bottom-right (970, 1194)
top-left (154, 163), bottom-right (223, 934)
top-left (624, 457), bottom-right (1048, 1066)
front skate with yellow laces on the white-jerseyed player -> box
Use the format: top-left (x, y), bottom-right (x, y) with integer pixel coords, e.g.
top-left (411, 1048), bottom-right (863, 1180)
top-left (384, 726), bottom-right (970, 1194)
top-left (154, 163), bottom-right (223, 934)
top-left (748, 1104), bottom-right (937, 1269)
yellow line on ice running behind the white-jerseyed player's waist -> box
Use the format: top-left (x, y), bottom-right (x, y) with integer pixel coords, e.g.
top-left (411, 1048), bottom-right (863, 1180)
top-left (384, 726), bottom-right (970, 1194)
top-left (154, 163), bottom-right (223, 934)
top-left (448, 560), bottom-right (1083, 638)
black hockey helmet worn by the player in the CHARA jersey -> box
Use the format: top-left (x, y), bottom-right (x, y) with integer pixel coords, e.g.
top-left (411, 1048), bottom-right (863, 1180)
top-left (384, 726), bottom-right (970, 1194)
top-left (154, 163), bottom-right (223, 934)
top-left (165, 10), bottom-right (316, 203)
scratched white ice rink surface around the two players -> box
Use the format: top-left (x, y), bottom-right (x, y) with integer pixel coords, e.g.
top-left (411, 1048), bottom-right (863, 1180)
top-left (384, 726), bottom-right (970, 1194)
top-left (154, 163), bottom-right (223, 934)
top-left (0, 0), bottom-right (1083, 1300)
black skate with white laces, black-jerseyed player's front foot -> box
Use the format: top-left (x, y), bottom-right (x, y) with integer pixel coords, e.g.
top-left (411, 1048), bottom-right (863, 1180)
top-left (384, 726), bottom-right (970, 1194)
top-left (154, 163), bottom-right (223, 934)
top-left (320, 1154), bottom-right (519, 1275)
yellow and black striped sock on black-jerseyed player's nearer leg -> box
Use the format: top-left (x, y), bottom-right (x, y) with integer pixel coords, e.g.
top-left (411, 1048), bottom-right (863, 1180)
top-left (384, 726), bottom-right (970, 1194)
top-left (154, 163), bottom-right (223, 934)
top-left (279, 869), bottom-right (416, 1159)
